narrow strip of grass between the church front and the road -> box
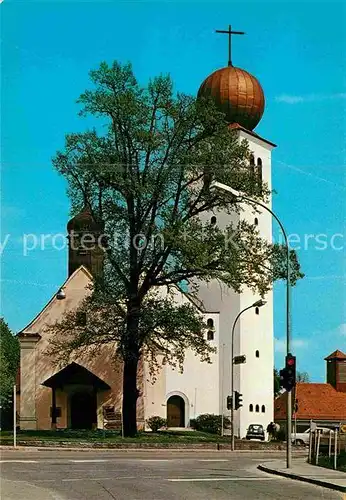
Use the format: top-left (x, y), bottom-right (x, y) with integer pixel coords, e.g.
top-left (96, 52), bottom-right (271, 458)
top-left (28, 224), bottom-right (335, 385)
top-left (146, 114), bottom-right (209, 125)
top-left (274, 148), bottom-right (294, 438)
top-left (0, 429), bottom-right (230, 445)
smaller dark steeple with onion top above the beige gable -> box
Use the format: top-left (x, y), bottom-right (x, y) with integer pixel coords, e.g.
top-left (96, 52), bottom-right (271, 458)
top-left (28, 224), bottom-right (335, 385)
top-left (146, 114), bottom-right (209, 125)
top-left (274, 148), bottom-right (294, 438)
top-left (67, 206), bottom-right (104, 276)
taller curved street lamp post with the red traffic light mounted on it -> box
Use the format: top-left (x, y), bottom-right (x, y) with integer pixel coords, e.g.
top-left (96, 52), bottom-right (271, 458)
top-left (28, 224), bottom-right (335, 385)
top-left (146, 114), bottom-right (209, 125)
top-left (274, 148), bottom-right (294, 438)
top-left (210, 181), bottom-right (292, 469)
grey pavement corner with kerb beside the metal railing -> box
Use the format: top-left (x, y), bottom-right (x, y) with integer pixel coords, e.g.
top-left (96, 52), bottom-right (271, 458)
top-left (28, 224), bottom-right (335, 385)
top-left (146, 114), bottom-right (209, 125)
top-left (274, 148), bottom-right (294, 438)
top-left (258, 458), bottom-right (346, 493)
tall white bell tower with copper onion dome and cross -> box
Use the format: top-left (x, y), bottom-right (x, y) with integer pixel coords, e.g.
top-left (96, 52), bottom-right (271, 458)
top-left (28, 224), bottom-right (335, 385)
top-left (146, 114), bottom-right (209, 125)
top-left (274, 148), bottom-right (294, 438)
top-left (198, 26), bottom-right (275, 437)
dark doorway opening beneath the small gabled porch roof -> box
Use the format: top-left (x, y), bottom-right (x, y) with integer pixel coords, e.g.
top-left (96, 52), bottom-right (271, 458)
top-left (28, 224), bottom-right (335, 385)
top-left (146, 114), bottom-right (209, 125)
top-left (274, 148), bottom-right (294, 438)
top-left (70, 391), bottom-right (97, 429)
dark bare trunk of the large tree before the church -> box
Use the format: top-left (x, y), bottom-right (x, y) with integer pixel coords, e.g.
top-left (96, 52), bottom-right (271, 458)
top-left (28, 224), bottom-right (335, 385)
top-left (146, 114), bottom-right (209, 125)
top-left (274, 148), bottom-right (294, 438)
top-left (123, 304), bottom-right (140, 437)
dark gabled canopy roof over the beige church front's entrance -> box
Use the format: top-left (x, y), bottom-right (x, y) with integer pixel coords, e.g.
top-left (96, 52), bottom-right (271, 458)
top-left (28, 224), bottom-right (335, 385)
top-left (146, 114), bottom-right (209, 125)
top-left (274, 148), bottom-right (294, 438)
top-left (42, 362), bottom-right (110, 391)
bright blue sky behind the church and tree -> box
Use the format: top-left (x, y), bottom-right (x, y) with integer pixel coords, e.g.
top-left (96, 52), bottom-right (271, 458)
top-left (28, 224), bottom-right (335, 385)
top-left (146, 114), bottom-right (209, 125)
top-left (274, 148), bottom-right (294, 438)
top-left (1, 0), bottom-right (346, 381)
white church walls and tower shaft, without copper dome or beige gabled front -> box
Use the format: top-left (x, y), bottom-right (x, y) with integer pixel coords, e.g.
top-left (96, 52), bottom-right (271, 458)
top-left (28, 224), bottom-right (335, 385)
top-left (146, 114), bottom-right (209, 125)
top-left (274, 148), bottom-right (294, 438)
top-left (145, 126), bottom-right (274, 437)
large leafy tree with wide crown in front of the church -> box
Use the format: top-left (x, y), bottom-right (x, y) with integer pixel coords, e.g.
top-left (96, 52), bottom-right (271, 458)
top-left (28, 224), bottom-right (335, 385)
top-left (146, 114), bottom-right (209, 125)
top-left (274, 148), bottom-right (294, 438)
top-left (53, 62), bottom-right (299, 436)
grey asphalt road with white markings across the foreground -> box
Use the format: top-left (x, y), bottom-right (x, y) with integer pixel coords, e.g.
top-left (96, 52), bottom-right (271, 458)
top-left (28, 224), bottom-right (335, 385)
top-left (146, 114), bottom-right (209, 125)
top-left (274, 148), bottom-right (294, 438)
top-left (0, 451), bottom-right (342, 500)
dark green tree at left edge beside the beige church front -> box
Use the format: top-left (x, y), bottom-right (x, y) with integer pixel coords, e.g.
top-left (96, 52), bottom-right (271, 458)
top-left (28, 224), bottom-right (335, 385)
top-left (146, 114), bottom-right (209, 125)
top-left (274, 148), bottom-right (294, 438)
top-left (0, 318), bottom-right (19, 408)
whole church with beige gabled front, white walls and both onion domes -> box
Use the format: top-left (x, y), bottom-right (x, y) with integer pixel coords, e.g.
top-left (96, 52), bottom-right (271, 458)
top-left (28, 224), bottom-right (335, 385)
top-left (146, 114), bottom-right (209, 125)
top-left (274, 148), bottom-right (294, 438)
top-left (18, 40), bottom-right (275, 437)
